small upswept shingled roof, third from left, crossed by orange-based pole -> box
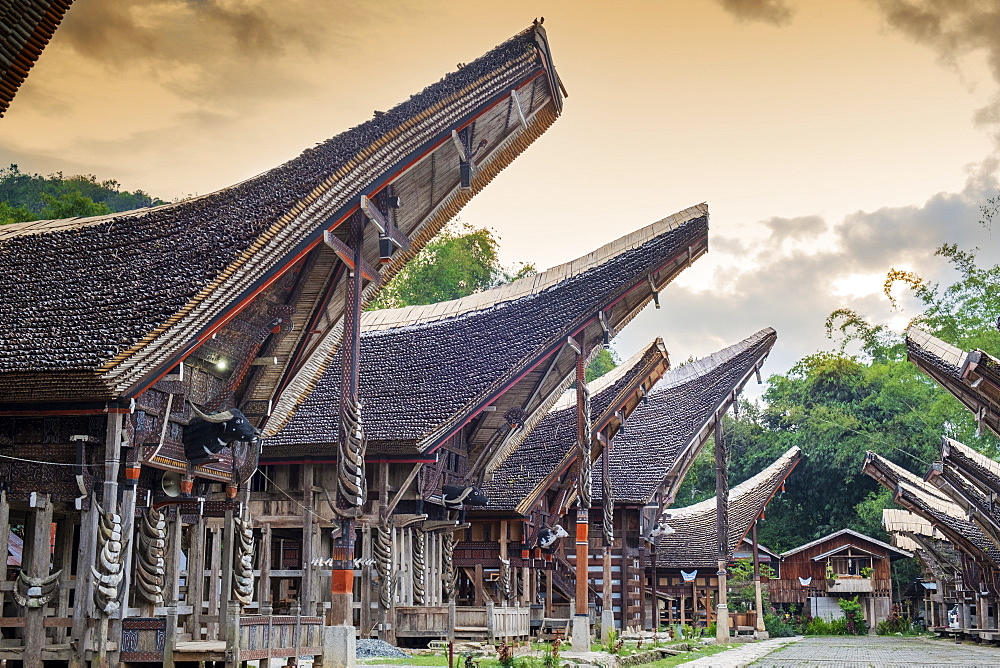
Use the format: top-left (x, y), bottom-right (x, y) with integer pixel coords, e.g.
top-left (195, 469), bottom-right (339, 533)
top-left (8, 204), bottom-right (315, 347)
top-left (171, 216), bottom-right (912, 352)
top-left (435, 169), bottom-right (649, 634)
top-left (483, 339), bottom-right (668, 514)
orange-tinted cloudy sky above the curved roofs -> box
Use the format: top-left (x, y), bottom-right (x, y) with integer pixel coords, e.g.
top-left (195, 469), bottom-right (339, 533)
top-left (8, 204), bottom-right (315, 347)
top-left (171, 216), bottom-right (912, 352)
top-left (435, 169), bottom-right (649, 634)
top-left (0, 0), bottom-right (1000, 388)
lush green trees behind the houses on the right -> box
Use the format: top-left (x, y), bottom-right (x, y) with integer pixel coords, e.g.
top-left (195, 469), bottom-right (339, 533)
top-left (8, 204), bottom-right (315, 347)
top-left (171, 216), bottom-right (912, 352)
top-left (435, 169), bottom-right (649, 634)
top-left (676, 245), bottom-right (1000, 551)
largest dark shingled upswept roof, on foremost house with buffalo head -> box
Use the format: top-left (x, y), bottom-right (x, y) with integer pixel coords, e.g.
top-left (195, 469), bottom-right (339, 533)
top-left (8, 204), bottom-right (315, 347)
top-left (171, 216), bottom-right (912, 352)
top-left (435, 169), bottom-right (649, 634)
top-left (0, 25), bottom-right (562, 422)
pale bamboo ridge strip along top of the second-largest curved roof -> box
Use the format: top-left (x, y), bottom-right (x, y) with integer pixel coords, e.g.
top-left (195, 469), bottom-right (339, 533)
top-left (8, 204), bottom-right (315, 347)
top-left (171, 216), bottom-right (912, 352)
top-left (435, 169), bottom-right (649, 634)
top-left (362, 202), bottom-right (708, 331)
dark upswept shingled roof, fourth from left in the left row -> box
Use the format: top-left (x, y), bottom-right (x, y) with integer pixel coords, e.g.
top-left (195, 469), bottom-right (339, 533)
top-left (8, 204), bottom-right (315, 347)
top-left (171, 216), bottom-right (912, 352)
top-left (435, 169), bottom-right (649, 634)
top-left (593, 327), bottom-right (777, 505)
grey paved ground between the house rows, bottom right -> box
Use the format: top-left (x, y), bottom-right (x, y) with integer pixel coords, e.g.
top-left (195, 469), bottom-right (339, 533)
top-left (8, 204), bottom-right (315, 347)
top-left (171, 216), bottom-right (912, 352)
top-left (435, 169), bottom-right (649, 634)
top-left (748, 636), bottom-right (1000, 668)
